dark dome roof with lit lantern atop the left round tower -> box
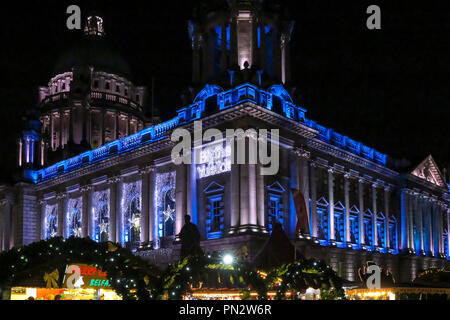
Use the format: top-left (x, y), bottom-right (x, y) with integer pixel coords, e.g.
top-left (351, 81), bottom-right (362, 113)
top-left (55, 17), bottom-right (131, 80)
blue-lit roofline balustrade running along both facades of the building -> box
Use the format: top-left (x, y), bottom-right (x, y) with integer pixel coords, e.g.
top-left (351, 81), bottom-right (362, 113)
top-left (30, 84), bottom-right (387, 183)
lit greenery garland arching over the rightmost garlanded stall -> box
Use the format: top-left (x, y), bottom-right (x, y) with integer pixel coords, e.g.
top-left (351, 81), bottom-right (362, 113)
top-left (266, 259), bottom-right (345, 300)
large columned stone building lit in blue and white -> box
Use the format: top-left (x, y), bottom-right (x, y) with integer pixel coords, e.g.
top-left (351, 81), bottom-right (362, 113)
top-left (0, 0), bottom-right (450, 281)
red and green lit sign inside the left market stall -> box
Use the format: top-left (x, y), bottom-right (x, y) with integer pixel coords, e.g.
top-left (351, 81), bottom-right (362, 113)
top-left (62, 264), bottom-right (111, 289)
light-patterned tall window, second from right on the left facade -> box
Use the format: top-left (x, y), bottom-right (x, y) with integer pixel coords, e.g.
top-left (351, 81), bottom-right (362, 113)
top-left (121, 181), bottom-right (142, 244)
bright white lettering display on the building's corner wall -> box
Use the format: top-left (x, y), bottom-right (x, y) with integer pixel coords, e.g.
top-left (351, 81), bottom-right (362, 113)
top-left (197, 144), bottom-right (231, 179)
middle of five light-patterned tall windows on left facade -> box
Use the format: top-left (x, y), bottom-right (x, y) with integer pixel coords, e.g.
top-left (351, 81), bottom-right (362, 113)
top-left (92, 189), bottom-right (110, 242)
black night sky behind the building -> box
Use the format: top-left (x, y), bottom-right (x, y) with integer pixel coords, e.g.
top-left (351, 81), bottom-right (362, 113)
top-left (0, 0), bottom-right (450, 179)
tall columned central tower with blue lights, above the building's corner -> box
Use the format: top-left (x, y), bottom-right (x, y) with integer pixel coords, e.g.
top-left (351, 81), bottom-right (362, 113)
top-left (189, 0), bottom-right (294, 87)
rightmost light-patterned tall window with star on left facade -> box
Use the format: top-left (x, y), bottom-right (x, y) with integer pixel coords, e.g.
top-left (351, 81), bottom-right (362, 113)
top-left (155, 171), bottom-right (176, 238)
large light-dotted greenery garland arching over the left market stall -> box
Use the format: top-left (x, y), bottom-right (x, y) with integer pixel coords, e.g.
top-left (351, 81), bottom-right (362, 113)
top-left (0, 237), bottom-right (159, 300)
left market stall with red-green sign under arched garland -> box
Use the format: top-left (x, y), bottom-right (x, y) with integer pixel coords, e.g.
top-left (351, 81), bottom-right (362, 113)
top-left (0, 237), bottom-right (158, 300)
